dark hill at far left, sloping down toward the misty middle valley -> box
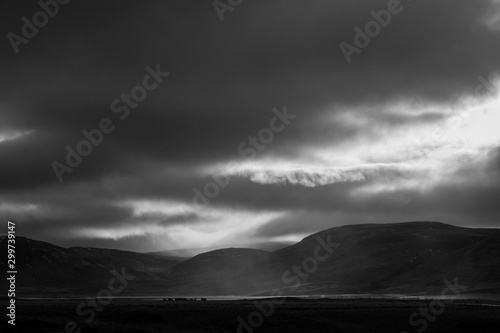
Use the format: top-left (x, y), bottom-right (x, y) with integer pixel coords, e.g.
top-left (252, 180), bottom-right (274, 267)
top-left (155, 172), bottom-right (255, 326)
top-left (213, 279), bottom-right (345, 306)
top-left (0, 236), bottom-right (182, 294)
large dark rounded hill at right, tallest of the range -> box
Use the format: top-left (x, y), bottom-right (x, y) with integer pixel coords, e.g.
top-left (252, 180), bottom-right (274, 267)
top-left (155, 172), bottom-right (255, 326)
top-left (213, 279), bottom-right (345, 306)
top-left (270, 222), bottom-right (500, 294)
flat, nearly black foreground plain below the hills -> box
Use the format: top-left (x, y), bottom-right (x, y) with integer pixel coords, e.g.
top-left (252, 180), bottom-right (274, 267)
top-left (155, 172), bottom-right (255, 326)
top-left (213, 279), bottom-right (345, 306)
top-left (0, 299), bottom-right (500, 333)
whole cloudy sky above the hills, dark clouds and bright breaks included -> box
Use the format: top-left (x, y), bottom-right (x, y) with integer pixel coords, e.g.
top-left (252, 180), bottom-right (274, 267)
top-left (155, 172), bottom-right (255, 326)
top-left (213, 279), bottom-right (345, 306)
top-left (0, 0), bottom-right (500, 251)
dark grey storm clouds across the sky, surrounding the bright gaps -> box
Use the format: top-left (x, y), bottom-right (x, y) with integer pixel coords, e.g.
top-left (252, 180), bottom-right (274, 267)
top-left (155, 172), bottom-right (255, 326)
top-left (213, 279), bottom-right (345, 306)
top-left (0, 0), bottom-right (500, 247)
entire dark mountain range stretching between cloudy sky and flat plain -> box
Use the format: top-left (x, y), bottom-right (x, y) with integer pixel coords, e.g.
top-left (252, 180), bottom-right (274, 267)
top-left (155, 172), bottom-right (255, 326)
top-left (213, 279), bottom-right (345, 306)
top-left (0, 222), bottom-right (500, 295)
